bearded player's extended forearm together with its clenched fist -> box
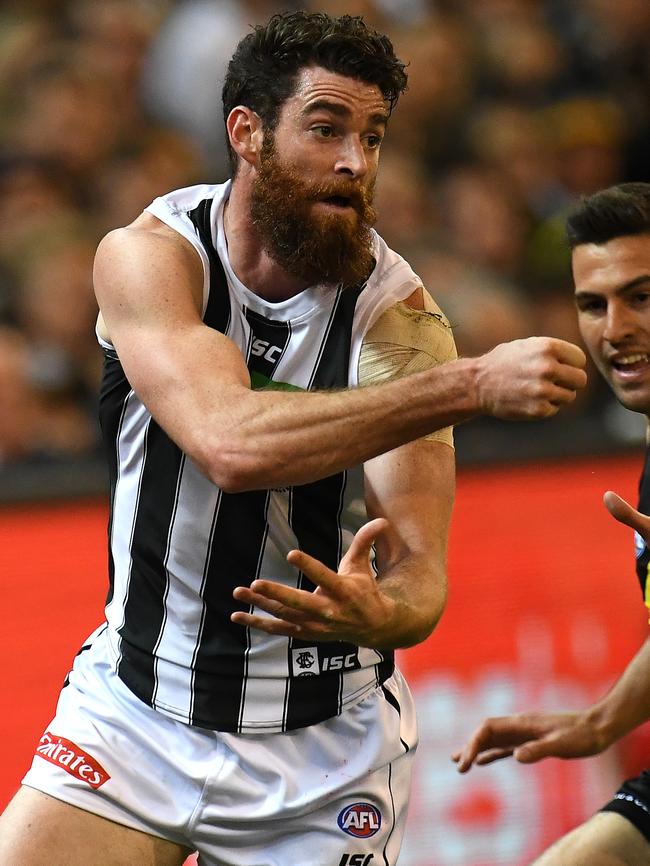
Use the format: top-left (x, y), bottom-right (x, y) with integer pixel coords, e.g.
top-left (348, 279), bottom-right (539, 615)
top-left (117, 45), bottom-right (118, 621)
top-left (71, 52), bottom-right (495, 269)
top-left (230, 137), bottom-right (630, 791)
top-left (187, 338), bottom-right (584, 490)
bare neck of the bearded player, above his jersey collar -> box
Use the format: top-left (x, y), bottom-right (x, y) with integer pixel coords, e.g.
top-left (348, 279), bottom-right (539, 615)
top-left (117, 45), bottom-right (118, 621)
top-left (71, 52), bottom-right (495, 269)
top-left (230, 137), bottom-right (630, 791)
top-left (223, 178), bottom-right (309, 301)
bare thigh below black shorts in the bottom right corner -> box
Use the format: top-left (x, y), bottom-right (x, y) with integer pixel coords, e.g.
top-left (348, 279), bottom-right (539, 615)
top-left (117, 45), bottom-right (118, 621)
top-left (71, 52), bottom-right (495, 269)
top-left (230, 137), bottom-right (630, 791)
top-left (532, 812), bottom-right (650, 866)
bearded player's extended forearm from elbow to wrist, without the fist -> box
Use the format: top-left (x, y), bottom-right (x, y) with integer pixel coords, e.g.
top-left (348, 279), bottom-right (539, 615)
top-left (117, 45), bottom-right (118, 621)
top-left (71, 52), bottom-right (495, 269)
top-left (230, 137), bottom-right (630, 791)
top-left (191, 360), bottom-right (478, 490)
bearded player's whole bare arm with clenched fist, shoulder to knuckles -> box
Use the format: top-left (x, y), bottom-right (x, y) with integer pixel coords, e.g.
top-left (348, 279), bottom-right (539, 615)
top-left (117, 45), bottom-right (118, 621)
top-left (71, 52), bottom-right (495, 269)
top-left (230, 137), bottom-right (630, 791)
top-left (95, 215), bottom-right (586, 491)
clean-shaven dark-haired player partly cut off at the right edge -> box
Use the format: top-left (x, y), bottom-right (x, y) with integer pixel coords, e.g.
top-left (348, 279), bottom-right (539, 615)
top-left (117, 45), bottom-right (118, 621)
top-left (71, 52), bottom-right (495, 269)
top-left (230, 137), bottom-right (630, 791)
top-left (453, 183), bottom-right (650, 866)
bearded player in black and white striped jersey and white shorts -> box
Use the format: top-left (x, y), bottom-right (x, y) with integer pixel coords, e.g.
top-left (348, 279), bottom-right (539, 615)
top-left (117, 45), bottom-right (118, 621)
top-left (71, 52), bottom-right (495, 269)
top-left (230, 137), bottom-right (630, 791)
top-left (0, 13), bottom-right (585, 866)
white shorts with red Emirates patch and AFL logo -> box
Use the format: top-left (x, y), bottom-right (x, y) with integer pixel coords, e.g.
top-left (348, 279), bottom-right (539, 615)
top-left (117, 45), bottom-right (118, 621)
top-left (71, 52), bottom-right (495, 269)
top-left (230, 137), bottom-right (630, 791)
top-left (23, 632), bottom-right (417, 866)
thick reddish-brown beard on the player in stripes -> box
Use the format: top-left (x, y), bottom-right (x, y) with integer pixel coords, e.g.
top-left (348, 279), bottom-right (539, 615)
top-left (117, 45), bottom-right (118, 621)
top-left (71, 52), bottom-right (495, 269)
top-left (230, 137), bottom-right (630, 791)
top-left (251, 136), bottom-right (376, 286)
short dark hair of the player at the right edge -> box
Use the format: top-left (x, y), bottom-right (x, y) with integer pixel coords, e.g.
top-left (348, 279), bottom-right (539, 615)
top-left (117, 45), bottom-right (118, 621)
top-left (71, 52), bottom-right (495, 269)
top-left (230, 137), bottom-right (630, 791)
top-left (566, 183), bottom-right (650, 249)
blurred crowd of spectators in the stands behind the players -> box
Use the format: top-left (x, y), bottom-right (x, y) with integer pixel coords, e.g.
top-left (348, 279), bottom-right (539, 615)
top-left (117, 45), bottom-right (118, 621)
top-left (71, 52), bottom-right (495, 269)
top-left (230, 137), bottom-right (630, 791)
top-left (0, 0), bottom-right (650, 477)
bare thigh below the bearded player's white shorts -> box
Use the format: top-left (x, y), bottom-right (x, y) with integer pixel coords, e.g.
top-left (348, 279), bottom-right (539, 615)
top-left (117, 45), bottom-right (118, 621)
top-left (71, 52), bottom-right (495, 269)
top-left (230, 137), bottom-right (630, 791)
top-left (0, 787), bottom-right (191, 866)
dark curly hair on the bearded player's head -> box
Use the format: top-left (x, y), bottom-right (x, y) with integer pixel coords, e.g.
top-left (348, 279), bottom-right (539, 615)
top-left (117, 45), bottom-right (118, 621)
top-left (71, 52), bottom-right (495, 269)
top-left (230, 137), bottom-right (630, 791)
top-left (222, 11), bottom-right (407, 170)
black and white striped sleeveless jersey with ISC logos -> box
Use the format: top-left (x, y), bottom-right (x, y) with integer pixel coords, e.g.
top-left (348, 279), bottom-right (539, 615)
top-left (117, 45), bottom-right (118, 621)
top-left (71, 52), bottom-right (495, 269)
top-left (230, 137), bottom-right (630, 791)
top-left (100, 184), bottom-right (419, 732)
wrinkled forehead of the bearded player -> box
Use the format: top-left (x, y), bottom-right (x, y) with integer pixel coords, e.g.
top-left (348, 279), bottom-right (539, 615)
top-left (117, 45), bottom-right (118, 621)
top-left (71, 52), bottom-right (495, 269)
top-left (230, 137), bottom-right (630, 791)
top-left (287, 66), bottom-right (389, 118)
